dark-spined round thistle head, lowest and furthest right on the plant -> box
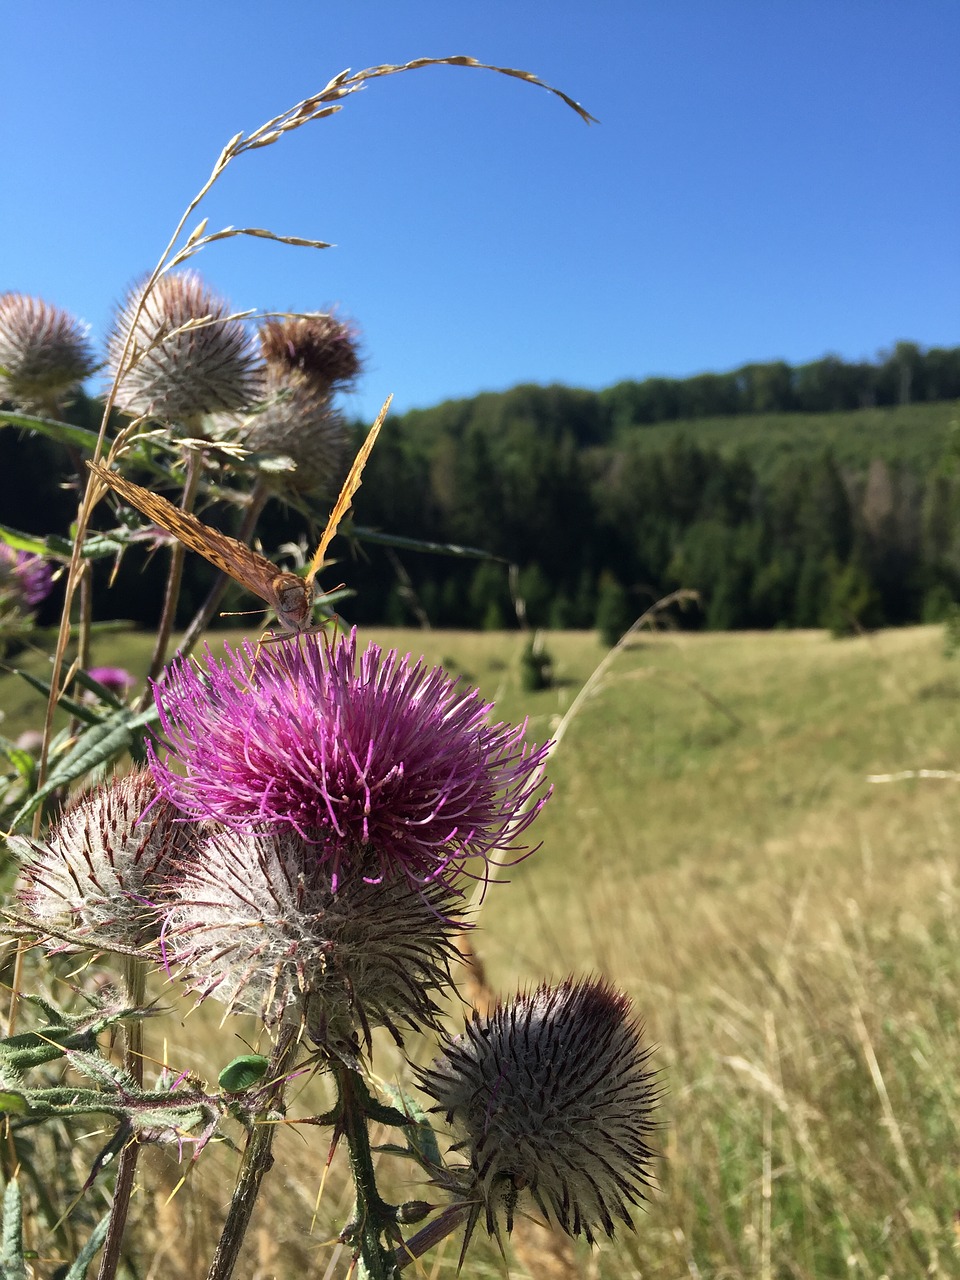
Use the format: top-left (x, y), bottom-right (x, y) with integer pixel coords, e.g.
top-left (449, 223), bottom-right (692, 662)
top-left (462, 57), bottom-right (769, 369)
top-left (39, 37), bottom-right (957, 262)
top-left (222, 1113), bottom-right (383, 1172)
top-left (420, 980), bottom-right (657, 1243)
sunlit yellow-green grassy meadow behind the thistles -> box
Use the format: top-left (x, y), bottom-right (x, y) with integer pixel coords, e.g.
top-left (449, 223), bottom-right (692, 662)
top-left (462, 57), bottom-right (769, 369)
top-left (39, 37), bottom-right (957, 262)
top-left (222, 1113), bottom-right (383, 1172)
top-left (0, 616), bottom-right (960, 1280)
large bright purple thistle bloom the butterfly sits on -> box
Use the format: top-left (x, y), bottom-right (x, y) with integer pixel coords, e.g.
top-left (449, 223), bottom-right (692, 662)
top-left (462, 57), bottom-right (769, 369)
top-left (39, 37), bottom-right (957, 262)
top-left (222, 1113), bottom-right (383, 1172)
top-left (148, 632), bottom-right (549, 890)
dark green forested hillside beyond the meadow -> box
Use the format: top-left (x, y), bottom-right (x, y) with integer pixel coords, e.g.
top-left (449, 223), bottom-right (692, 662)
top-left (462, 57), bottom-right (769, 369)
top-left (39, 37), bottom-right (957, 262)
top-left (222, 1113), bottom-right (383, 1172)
top-left (0, 342), bottom-right (960, 634)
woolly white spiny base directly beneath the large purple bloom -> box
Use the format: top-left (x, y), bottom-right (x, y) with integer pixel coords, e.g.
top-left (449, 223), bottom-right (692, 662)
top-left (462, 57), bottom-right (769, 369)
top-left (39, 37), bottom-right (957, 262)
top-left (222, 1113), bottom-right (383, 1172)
top-left (164, 831), bottom-right (462, 1050)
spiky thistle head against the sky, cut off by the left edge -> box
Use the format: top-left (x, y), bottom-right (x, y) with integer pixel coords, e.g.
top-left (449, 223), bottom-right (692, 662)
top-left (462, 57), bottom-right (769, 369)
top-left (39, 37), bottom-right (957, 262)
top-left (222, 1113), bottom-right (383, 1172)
top-left (0, 293), bottom-right (95, 410)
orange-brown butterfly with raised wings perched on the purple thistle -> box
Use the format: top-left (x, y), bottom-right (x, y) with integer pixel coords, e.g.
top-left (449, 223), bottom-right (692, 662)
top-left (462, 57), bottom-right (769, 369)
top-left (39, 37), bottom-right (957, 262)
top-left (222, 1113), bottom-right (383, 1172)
top-left (87, 396), bottom-right (393, 632)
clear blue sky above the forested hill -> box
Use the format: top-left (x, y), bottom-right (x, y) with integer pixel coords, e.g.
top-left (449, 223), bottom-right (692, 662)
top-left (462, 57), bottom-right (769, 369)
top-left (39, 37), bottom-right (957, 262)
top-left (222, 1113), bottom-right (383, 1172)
top-left (0, 0), bottom-right (960, 416)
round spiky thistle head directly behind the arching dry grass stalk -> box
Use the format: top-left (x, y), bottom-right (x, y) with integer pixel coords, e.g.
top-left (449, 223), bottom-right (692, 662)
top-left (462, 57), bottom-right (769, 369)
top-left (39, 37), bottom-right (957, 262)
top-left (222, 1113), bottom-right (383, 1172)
top-left (109, 271), bottom-right (260, 422)
